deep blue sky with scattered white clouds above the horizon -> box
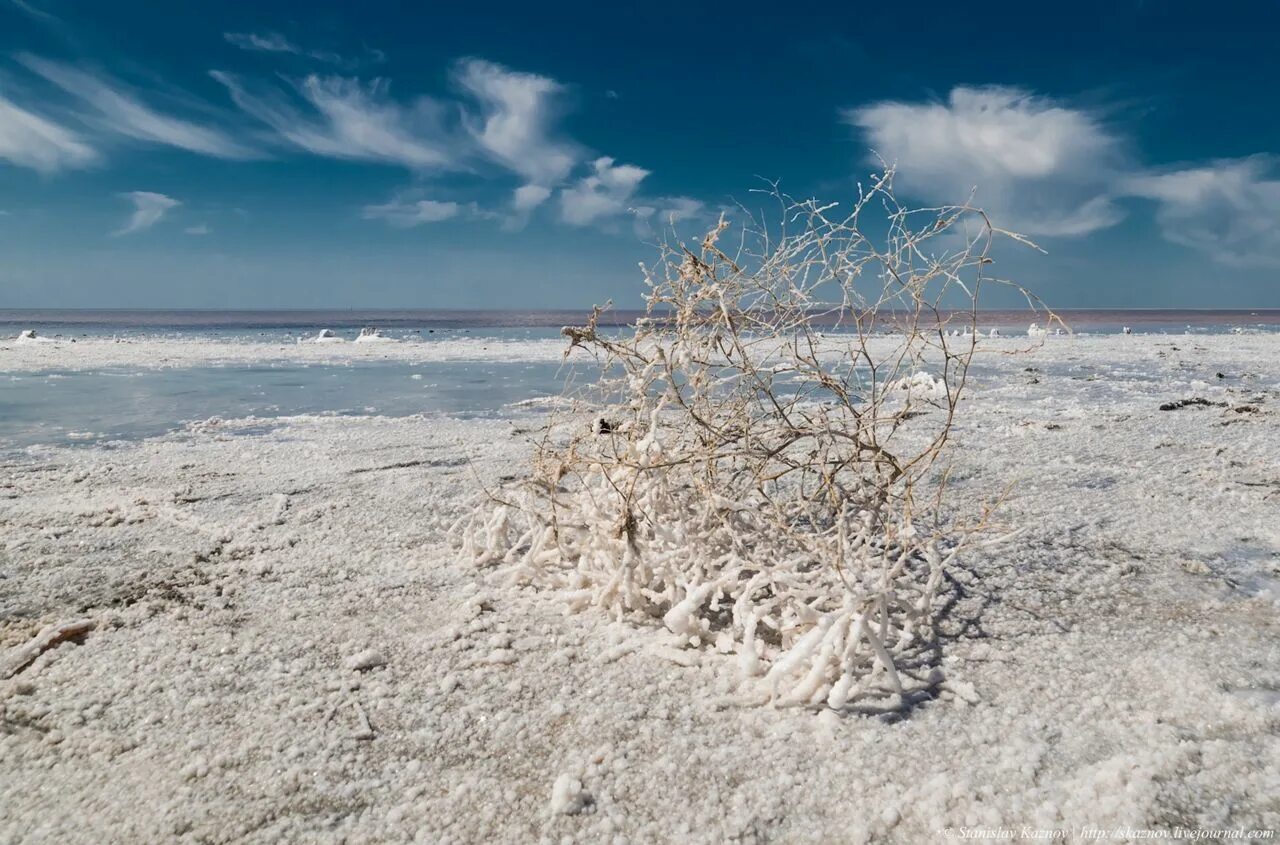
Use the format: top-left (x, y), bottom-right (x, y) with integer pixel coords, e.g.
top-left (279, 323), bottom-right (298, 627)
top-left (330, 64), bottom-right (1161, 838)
top-left (0, 0), bottom-right (1280, 307)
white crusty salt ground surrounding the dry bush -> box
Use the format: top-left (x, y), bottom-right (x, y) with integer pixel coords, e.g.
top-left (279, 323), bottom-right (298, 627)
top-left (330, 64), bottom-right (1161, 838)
top-left (0, 335), bottom-right (1280, 842)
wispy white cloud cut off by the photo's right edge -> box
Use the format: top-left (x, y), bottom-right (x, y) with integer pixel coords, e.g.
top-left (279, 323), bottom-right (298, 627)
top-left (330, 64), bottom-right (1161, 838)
top-left (1124, 156), bottom-right (1280, 268)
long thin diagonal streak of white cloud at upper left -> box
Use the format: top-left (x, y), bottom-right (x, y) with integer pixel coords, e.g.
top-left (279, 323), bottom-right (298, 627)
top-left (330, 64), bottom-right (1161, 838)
top-left (18, 55), bottom-right (255, 159)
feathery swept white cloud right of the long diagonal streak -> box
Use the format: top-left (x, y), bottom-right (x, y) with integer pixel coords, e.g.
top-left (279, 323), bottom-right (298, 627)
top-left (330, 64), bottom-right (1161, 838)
top-left (211, 70), bottom-right (460, 170)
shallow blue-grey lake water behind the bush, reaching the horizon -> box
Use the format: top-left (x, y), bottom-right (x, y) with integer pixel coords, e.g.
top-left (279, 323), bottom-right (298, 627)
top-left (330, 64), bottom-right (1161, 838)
top-left (0, 310), bottom-right (1280, 452)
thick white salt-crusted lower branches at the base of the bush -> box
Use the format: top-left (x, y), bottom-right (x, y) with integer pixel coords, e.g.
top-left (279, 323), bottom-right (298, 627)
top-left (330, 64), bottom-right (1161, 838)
top-left (454, 479), bottom-right (957, 711)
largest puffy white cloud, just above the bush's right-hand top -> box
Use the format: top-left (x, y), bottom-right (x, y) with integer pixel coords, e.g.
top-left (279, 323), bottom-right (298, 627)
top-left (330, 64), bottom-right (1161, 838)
top-left (844, 86), bottom-right (1125, 237)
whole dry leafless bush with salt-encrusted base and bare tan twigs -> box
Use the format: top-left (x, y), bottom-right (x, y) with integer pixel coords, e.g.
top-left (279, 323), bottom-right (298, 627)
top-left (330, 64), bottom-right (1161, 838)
top-left (457, 169), bottom-right (1044, 709)
